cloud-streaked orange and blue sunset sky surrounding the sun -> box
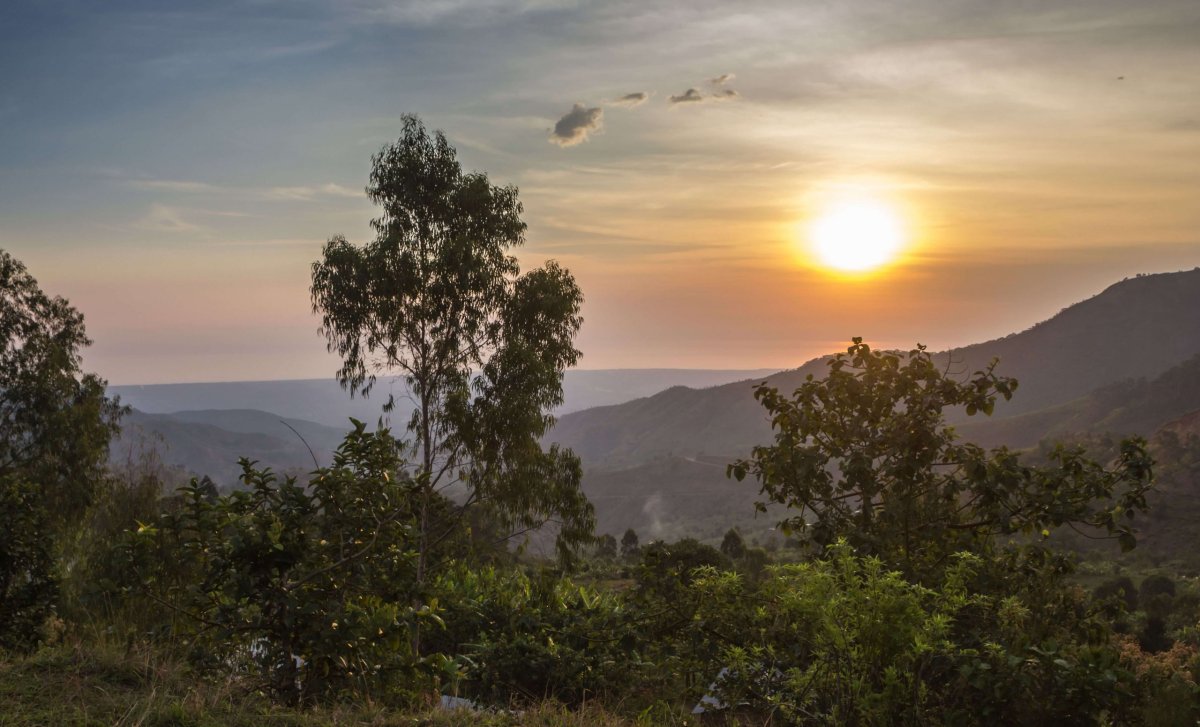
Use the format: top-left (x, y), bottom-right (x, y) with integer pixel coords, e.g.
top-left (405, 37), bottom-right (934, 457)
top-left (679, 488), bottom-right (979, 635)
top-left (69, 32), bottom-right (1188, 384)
top-left (0, 0), bottom-right (1200, 384)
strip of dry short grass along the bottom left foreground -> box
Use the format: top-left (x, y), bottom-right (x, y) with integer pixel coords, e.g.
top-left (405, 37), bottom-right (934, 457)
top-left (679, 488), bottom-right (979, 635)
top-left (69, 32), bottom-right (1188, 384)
top-left (0, 643), bottom-right (739, 727)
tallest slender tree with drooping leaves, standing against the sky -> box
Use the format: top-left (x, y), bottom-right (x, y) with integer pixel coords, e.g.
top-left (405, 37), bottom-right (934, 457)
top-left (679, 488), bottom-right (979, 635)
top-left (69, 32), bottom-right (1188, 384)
top-left (312, 116), bottom-right (594, 583)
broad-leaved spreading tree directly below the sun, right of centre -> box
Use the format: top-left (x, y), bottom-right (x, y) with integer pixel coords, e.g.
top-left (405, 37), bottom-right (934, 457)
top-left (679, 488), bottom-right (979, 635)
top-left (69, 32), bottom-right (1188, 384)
top-left (728, 338), bottom-right (1152, 572)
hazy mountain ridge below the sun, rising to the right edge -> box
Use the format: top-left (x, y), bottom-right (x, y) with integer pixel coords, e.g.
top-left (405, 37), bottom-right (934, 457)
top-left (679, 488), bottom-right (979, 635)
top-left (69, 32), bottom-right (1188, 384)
top-left (550, 269), bottom-right (1200, 470)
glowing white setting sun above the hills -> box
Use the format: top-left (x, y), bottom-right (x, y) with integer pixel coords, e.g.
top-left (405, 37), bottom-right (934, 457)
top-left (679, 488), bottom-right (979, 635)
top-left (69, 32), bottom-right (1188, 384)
top-left (808, 196), bottom-right (905, 272)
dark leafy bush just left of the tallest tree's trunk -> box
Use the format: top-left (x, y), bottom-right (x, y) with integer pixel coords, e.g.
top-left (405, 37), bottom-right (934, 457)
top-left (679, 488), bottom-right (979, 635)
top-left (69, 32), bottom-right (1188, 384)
top-left (130, 422), bottom-right (437, 702)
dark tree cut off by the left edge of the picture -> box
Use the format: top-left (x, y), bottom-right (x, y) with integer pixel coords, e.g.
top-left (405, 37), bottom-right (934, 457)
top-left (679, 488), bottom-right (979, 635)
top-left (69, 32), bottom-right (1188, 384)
top-left (0, 250), bottom-right (122, 648)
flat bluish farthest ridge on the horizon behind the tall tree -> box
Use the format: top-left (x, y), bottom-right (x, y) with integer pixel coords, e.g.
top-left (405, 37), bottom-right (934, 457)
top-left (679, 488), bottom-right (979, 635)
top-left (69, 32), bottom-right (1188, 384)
top-left (109, 368), bottom-right (774, 431)
